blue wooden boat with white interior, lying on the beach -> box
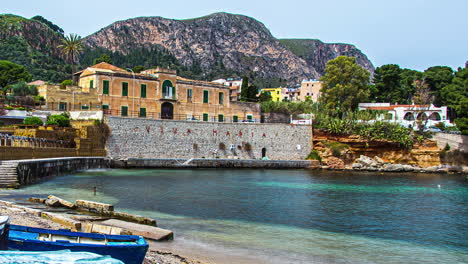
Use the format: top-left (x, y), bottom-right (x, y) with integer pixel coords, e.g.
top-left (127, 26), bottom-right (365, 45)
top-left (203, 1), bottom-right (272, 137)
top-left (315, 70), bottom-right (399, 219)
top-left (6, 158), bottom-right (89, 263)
top-left (8, 225), bottom-right (148, 264)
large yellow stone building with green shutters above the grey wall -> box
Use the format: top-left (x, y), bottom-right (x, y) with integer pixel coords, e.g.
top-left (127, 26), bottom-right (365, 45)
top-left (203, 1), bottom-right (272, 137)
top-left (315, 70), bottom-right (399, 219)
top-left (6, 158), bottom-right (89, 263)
top-left (38, 62), bottom-right (260, 122)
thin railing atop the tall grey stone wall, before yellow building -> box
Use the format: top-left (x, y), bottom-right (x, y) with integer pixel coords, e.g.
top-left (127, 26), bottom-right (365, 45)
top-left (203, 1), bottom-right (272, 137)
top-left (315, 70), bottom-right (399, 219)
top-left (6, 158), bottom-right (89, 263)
top-left (103, 109), bottom-right (260, 123)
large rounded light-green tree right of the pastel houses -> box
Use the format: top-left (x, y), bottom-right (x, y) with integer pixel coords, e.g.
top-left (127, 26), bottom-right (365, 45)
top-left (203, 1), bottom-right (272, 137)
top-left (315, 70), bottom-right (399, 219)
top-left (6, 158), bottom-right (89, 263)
top-left (320, 56), bottom-right (370, 114)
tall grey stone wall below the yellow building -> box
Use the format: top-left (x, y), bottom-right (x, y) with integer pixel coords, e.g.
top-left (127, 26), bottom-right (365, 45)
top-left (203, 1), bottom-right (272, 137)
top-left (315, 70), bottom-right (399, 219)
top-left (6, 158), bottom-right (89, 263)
top-left (105, 116), bottom-right (312, 160)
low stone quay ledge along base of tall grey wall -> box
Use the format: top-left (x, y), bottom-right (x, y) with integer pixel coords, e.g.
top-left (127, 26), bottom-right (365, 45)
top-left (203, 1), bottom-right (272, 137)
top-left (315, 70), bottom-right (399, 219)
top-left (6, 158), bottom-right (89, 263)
top-left (112, 158), bottom-right (320, 169)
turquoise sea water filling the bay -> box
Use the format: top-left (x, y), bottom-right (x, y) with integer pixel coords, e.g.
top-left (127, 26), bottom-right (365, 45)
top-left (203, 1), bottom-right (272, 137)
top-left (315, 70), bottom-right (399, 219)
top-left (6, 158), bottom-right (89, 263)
top-left (0, 170), bottom-right (468, 263)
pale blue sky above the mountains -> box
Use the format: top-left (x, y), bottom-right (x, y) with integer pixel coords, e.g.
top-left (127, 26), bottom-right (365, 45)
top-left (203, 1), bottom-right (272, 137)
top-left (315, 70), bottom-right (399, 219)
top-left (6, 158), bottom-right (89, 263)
top-left (0, 0), bottom-right (468, 70)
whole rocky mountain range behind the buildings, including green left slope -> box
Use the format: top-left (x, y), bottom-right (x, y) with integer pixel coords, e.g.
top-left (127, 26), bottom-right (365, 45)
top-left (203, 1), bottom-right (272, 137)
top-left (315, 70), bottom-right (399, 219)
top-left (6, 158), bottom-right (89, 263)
top-left (0, 13), bottom-right (374, 87)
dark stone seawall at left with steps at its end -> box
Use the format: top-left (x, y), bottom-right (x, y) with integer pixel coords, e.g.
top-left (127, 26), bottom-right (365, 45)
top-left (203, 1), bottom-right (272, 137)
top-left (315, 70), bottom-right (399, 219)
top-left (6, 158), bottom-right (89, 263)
top-left (0, 157), bottom-right (110, 188)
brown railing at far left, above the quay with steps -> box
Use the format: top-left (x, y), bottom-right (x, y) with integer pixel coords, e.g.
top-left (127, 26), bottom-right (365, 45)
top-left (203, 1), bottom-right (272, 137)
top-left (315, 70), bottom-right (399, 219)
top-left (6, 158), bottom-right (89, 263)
top-left (0, 134), bottom-right (75, 148)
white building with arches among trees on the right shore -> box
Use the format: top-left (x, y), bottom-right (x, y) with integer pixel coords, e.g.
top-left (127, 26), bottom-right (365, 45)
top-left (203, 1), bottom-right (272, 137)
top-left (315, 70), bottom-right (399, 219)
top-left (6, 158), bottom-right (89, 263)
top-left (359, 103), bottom-right (453, 129)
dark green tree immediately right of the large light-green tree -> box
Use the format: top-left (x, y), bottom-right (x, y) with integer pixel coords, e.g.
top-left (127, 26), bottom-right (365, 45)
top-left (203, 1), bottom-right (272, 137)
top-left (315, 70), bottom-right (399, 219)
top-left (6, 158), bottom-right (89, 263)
top-left (372, 64), bottom-right (403, 103)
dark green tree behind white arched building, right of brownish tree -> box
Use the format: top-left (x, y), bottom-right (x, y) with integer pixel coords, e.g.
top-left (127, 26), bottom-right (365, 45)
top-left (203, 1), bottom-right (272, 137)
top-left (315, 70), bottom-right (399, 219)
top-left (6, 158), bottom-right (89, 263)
top-left (424, 66), bottom-right (454, 106)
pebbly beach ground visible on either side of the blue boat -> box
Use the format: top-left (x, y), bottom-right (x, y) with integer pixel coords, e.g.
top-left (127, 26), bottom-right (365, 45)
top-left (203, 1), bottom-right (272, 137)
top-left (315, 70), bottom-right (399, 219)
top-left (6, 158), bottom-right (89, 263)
top-left (0, 205), bottom-right (204, 264)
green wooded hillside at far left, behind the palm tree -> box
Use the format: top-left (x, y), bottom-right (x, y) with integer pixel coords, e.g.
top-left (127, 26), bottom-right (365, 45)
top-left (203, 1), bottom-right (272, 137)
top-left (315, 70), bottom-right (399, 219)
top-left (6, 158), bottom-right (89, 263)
top-left (0, 14), bottom-right (71, 82)
